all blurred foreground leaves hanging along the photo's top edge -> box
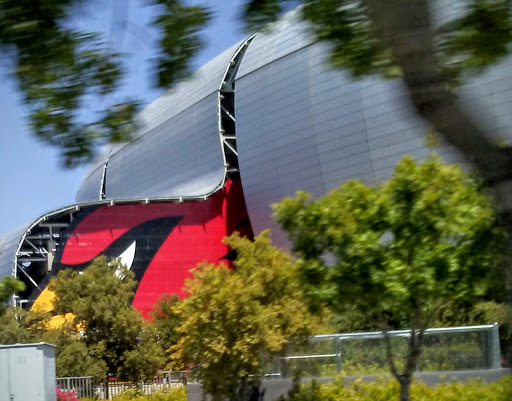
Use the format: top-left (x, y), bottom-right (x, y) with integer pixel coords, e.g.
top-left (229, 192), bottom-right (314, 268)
top-left (0, 0), bottom-right (512, 166)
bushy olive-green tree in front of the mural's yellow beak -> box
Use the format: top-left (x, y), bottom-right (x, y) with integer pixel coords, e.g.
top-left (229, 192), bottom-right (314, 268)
top-left (49, 257), bottom-right (163, 380)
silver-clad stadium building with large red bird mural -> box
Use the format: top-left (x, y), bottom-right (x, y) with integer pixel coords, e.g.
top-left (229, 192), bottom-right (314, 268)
top-left (0, 0), bottom-right (512, 313)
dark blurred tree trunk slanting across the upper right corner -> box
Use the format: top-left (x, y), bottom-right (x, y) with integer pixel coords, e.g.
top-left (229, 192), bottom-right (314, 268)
top-left (364, 0), bottom-right (512, 214)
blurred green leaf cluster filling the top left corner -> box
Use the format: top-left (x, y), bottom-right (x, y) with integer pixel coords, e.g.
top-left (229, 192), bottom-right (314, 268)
top-left (0, 0), bottom-right (141, 166)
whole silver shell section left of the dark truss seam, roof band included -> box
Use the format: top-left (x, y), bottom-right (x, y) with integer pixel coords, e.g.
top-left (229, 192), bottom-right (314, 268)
top-left (76, 42), bottom-right (246, 202)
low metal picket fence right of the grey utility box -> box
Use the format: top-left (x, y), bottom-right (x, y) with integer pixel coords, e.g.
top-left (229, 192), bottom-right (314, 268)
top-left (57, 371), bottom-right (188, 400)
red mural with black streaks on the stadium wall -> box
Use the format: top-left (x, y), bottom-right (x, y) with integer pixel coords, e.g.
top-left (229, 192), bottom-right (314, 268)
top-left (56, 180), bottom-right (252, 316)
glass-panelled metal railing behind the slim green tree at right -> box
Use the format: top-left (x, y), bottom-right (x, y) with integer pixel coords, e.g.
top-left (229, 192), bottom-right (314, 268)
top-left (272, 323), bottom-right (501, 377)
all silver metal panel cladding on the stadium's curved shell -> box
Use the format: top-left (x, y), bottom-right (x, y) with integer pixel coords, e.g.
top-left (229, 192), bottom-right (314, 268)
top-left (0, 0), bottom-right (512, 298)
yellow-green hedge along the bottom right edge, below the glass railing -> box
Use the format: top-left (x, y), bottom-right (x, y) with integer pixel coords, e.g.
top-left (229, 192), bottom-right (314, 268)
top-left (284, 376), bottom-right (512, 401)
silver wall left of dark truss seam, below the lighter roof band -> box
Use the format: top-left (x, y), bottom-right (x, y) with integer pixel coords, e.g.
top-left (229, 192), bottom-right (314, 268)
top-left (106, 93), bottom-right (224, 199)
